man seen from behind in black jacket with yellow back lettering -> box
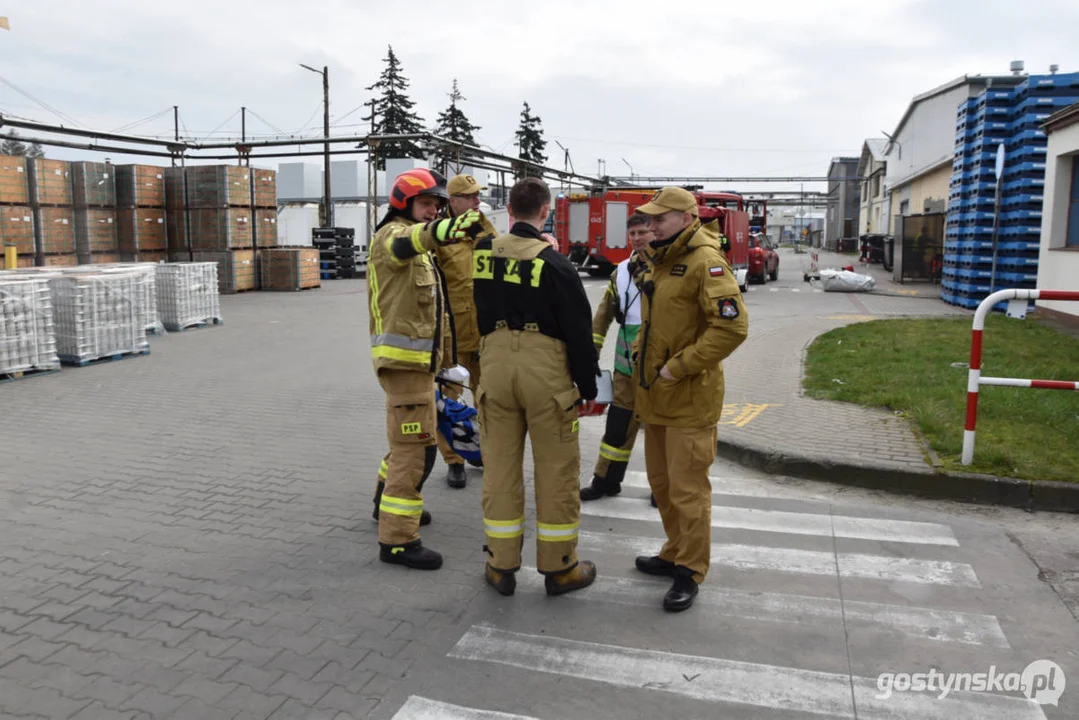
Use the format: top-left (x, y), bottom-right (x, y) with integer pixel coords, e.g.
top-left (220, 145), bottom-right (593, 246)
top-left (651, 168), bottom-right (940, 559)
top-left (473, 178), bottom-right (599, 595)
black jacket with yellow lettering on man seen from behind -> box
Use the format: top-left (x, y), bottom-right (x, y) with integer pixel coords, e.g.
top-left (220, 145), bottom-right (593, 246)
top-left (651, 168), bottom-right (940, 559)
top-left (473, 222), bottom-right (600, 399)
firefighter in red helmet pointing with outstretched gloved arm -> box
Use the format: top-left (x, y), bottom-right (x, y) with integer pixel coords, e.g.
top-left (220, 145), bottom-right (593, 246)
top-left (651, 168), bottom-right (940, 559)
top-left (367, 168), bottom-right (481, 570)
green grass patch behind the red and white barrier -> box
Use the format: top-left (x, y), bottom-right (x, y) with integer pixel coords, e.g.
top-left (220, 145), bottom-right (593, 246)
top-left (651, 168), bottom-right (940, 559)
top-left (805, 314), bottom-right (1079, 481)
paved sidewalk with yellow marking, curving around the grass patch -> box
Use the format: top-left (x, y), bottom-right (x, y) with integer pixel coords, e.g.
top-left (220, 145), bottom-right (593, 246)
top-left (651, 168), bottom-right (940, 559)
top-left (720, 250), bottom-right (969, 479)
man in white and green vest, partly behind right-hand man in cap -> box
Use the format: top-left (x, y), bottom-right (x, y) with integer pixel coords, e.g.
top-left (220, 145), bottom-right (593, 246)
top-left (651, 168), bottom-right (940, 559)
top-left (581, 214), bottom-right (653, 502)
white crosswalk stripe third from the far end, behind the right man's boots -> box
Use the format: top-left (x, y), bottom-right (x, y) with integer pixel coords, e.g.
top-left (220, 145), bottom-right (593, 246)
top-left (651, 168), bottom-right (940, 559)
top-left (579, 530), bottom-right (982, 587)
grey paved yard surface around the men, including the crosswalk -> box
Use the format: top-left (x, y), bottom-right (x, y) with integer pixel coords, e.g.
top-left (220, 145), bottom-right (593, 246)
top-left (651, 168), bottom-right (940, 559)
top-left (0, 266), bottom-right (1079, 720)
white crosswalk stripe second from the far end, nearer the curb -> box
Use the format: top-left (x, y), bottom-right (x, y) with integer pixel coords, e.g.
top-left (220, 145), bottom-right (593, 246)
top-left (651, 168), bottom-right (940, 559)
top-left (581, 498), bottom-right (959, 547)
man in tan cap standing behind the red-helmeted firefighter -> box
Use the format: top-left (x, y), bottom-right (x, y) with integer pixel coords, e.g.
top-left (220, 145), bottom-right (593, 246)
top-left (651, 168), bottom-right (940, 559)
top-left (435, 175), bottom-right (498, 489)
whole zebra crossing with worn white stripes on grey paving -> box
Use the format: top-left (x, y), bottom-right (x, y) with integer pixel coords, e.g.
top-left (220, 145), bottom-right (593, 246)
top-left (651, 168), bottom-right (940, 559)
top-left (393, 472), bottom-right (1055, 720)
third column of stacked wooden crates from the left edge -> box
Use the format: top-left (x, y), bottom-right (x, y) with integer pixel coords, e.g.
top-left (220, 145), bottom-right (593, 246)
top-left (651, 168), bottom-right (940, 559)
top-left (71, 162), bottom-right (120, 264)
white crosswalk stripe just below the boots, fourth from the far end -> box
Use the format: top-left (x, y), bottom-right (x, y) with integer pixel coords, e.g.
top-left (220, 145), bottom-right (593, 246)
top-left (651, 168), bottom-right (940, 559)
top-left (517, 566), bottom-right (1010, 649)
